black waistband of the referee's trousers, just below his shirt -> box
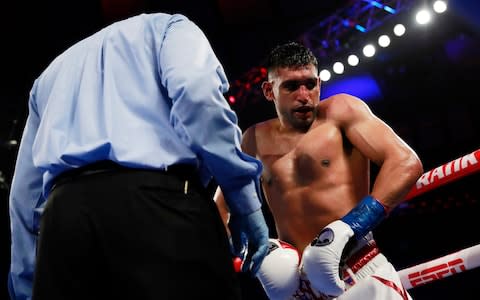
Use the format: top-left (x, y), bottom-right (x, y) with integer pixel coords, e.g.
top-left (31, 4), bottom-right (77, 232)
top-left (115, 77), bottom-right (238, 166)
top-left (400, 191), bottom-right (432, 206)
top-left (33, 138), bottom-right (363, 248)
top-left (50, 160), bottom-right (204, 194)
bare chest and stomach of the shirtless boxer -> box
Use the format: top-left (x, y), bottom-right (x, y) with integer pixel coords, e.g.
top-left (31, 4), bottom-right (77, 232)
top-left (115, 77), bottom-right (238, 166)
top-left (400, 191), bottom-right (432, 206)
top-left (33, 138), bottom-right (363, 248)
top-left (251, 113), bottom-right (369, 250)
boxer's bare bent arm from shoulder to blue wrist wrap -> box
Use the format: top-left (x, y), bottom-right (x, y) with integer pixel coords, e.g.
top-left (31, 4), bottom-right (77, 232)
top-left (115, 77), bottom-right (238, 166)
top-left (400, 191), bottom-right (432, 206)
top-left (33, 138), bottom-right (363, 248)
top-left (328, 94), bottom-right (423, 209)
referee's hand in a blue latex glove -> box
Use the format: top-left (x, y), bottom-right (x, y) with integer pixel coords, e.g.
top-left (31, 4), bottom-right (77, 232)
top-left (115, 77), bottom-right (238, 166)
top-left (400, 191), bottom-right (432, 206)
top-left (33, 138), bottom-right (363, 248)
top-left (228, 209), bottom-right (268, 276)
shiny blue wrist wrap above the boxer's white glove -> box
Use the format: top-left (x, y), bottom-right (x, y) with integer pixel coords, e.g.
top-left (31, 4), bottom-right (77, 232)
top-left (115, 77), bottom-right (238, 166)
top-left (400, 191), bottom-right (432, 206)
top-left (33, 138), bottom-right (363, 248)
top-left (341, 195), bottom-right (386, 238)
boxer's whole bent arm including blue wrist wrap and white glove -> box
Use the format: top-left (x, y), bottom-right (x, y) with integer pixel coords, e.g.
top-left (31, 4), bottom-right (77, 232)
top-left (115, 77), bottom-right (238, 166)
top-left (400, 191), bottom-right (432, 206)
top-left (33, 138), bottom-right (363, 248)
top-left (302, 94), bottom-right (423, 296)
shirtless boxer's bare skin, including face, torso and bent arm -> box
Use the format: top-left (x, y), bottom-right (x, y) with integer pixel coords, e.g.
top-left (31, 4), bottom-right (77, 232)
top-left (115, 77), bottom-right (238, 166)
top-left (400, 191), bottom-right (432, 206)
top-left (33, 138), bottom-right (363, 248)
top-left (215, 65), bottom-right (423, 253)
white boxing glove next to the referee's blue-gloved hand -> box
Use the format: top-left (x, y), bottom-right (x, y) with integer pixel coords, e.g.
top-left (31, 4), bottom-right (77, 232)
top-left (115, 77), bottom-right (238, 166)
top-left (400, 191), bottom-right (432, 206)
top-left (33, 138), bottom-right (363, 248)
top-left (257, 239), bottom-right (300, 300)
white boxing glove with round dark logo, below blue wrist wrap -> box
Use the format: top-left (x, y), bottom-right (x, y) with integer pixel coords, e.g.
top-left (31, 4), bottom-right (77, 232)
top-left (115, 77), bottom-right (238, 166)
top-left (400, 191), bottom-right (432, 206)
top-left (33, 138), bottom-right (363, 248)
top-left (301, 220), bottom-right (354, 297)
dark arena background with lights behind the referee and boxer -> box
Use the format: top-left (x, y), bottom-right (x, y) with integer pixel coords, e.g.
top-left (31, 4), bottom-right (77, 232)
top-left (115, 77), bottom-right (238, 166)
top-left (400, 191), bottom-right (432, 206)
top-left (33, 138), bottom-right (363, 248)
top-left (0, 0), bottom-right (480, 300)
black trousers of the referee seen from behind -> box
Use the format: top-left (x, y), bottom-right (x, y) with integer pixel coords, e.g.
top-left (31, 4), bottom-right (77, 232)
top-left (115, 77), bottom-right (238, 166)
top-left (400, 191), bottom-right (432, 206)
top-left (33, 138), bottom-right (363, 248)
top-left (33, 164), bottom-right (241, 300)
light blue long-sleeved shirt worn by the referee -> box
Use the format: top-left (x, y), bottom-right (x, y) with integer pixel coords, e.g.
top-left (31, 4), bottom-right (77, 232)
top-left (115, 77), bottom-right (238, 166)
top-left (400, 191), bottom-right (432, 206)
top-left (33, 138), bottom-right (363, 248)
top-left (9, 14), bottom-right (262, 299)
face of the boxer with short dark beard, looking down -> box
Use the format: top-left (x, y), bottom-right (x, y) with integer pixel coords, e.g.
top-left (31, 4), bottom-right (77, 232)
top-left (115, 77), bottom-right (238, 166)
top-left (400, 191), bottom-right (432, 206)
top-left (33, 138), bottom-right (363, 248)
top-left (262, 65), bottom-right (320, 130)
